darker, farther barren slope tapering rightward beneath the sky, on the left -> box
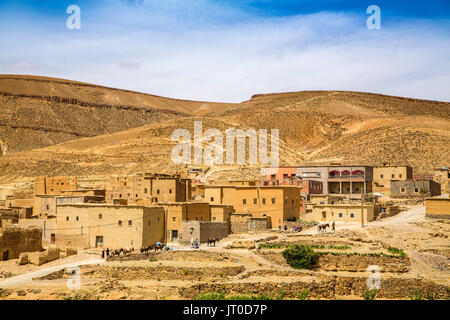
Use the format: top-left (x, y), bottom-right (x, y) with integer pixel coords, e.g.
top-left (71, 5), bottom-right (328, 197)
top-left (0, 75), bottom-right (237, 152)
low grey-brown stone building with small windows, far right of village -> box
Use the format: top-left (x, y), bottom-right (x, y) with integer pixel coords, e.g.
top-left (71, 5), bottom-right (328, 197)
top-left (391, 179), bottom-right (441, 198)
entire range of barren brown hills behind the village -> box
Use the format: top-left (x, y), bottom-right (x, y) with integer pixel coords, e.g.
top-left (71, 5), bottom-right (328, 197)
top-left (0, 76), bottom-right (450, 182)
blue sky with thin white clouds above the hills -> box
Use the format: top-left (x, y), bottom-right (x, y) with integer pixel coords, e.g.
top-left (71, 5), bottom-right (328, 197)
top-left (0, 0), bottom-right (450, 102)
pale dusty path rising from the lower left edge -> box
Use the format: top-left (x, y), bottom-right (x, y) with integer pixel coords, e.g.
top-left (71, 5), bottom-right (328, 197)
top-left (0, 258), bottom-right (105, 288)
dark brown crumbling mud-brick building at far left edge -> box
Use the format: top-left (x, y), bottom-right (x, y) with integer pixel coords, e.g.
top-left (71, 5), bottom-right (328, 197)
top-left (0, 226), bottom-right (42, 261)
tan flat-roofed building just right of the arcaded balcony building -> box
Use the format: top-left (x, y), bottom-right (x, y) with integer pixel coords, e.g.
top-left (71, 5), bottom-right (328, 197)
top-left (372, 166), bottom-right (413, 193)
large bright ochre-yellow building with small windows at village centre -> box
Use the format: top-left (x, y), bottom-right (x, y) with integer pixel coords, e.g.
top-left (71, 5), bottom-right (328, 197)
top-left (205, 185), bottom-right (302, 228)
